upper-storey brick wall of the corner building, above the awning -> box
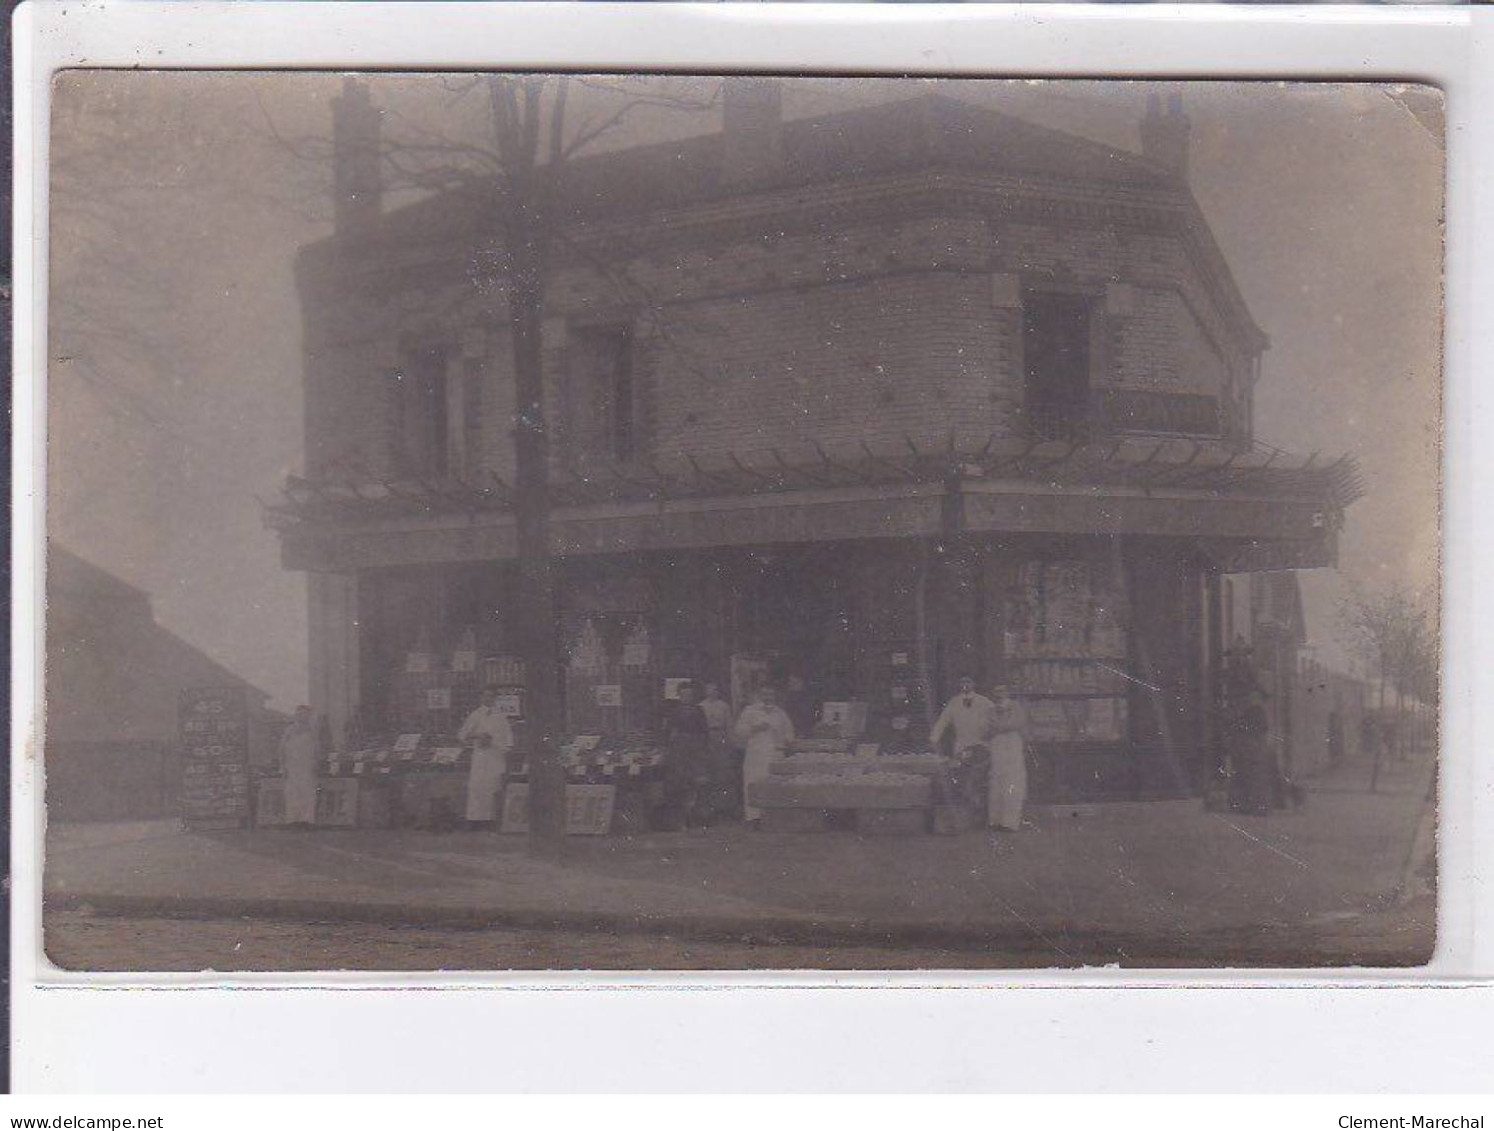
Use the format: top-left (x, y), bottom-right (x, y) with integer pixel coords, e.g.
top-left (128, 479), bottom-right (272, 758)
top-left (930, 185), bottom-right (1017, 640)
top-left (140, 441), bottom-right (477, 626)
top-left (300, 111), bottom-right (1264, 480)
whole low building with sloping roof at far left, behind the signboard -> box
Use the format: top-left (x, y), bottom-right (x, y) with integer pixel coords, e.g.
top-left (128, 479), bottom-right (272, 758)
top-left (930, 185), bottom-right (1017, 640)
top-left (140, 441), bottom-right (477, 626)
top-left (46, 542), bottom-right (279, 820)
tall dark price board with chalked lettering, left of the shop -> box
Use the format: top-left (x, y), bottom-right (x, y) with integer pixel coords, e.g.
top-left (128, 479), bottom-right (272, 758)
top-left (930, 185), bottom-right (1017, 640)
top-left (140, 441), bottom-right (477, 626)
top-left (179, 687), bottom-right (249, 829)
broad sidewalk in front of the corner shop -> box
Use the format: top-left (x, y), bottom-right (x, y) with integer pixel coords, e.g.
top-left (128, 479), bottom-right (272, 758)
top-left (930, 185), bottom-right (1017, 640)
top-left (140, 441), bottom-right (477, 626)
top-left (46, 753), bottom-right (1433, 968)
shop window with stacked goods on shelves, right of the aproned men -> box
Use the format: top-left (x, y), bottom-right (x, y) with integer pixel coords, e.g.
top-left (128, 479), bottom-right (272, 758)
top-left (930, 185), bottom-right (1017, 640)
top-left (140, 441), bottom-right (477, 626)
top-left (1004, 560), bottom-right (1128, 744)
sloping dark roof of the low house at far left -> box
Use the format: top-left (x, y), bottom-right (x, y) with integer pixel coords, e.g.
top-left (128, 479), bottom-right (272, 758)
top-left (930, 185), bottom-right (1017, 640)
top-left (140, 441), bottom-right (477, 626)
top-left (46, 542), bottom-right (269, 743)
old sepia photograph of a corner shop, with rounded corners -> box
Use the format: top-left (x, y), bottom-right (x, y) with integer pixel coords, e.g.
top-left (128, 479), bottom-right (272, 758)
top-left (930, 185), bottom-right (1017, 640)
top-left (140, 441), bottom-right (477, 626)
top-left (42, 70), bottom-right (1445, 973)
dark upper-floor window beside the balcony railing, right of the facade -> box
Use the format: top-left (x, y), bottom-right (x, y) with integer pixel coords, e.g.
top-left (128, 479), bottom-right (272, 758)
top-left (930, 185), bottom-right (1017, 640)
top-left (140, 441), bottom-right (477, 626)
top-left (1022, 291), bottom-right (1092, 441)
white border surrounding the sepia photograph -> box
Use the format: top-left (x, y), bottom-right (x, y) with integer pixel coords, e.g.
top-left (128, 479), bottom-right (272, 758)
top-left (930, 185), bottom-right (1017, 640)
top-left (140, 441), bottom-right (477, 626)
top-left (12, 3), bottom-right (1494, 1091)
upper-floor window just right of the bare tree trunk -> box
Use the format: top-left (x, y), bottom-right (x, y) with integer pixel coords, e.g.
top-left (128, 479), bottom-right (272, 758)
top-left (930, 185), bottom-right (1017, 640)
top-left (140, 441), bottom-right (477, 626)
top-left (565, 326), bottom-right (638, 462)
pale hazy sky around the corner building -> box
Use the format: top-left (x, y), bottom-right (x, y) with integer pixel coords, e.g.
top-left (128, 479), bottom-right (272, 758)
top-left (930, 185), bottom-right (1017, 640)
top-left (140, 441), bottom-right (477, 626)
top-left (49, 72), bottom-right (1443, 707)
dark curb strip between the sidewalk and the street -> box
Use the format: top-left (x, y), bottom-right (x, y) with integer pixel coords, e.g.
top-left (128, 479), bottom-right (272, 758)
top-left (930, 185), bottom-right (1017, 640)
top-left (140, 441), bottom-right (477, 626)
top-left (45, 893), bottom-right (1431, 971)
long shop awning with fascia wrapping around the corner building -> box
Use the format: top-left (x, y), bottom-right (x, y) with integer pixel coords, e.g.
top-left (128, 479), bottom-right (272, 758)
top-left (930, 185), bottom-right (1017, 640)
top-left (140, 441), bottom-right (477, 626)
top-left (266, 436), bottom-right (1363, 569)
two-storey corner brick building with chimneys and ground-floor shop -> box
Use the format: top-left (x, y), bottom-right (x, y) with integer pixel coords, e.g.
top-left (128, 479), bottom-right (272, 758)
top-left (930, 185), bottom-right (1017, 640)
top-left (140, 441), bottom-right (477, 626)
top-left (275, 81), bottom-right (1358, 798)
